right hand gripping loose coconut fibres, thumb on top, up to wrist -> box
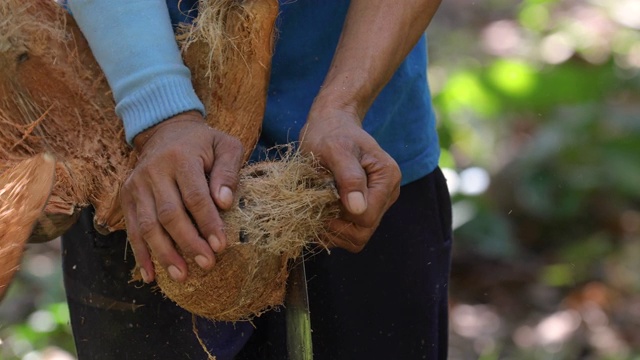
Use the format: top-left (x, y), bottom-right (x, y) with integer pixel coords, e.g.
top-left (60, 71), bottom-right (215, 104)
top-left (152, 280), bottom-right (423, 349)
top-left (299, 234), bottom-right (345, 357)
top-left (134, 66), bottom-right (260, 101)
top-left (300, 106), bottom-right (401, 252)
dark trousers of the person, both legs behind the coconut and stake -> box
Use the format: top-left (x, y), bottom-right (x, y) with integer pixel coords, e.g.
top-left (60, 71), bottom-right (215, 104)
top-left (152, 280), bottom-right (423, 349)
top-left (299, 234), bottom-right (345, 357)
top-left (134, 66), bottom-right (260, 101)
top-left (63, 170), bottom-right (451, 360)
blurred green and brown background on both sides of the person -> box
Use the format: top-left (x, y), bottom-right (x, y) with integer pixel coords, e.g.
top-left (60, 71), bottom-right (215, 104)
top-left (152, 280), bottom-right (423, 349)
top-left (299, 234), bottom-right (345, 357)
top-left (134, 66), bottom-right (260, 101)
top-left (0, 0), bottom-right (640, 360)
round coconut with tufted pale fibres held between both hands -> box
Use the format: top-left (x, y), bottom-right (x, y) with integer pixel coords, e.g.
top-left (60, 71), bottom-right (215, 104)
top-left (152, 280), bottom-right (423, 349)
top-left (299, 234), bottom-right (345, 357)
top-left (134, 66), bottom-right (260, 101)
top-left (155, 152), bottom-right (340, 321)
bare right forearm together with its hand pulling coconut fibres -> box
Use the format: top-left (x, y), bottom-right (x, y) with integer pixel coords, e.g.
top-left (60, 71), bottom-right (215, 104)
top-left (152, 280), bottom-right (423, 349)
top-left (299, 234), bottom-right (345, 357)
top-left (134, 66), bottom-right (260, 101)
top-left (292, 0), bottom-right (440, 252)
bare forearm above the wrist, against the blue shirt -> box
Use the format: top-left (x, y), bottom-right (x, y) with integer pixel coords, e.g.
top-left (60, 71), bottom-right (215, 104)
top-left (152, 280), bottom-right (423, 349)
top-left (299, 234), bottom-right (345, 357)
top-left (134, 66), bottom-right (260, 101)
top-left (316, 0), bottom-right (440, 119)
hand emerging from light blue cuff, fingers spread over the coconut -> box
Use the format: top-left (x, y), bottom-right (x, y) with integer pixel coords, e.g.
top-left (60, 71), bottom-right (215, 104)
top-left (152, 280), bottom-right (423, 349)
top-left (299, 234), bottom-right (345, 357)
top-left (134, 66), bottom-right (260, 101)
top-left (121, 111), bottom-right (242, 282)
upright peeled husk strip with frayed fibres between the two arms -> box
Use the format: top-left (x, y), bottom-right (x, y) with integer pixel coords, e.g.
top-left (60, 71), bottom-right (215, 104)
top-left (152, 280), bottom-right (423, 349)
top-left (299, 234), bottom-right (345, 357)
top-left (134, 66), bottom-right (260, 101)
top-left (178, 0), bottom-right (278, 160)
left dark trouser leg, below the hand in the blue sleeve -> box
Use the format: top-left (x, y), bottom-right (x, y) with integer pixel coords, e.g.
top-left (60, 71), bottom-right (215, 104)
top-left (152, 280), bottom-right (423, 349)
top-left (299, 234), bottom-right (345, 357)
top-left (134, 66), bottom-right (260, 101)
top-left (62, 209), bottom-right (253, 360)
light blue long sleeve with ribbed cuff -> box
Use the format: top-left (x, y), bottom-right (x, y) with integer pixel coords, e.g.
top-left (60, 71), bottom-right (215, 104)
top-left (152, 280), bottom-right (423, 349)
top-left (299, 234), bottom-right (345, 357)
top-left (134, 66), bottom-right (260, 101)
top-left (68, 0), bottom-right (205, 144)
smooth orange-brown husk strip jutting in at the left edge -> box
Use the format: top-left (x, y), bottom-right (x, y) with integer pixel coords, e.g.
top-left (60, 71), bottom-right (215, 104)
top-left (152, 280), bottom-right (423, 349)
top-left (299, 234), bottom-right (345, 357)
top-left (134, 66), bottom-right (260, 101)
top-left (0, 154), bottom-right (55, 299)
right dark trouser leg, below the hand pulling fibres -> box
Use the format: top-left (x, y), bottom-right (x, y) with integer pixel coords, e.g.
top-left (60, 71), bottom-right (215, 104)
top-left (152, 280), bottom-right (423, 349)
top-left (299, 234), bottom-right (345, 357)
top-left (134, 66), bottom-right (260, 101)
top-left (239, 169), bottom-right (451, 360)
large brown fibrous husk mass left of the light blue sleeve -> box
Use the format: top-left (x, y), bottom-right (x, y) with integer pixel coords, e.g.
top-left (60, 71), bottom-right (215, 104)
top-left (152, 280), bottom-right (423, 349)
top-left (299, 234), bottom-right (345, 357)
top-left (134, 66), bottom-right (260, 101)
top-left (0, 0), bottom-right (130, 240)
